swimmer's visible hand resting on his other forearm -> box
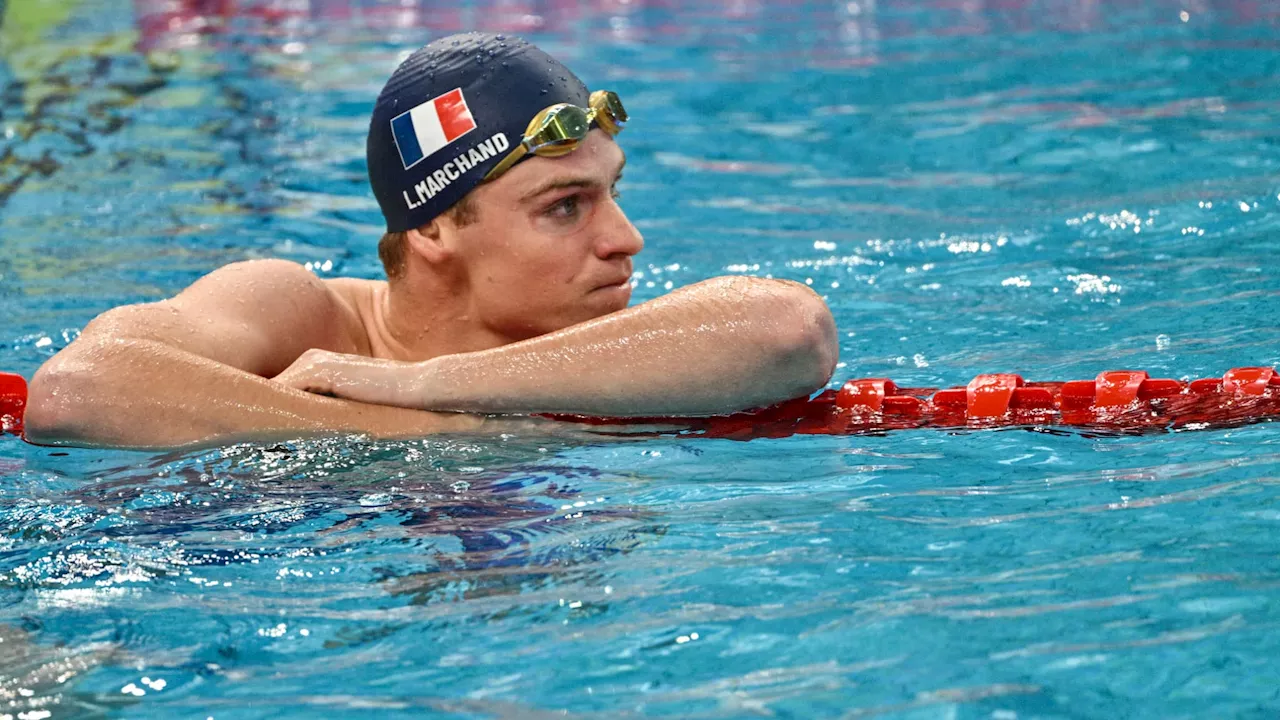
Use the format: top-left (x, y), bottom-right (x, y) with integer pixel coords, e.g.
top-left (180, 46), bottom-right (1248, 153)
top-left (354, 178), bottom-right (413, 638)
top-left (273, 350), bottom-right (417, 405)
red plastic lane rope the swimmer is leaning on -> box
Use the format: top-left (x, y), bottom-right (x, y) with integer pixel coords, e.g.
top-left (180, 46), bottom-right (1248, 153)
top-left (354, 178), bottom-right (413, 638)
top-left (0, 368), bottom-right (1280, 439)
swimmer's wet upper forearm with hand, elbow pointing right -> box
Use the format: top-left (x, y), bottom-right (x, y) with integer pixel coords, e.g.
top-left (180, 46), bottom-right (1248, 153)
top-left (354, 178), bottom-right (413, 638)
top-left (278, 277), bottom-right (838, 416)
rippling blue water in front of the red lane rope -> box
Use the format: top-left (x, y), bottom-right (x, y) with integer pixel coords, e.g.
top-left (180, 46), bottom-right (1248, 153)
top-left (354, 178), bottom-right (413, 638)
top-left (0, 428), bottom-right (1280, 716)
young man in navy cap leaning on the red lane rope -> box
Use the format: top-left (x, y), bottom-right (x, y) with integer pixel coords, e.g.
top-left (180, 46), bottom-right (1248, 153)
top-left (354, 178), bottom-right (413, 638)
top-left (26, 33), bottom-right (837, 447)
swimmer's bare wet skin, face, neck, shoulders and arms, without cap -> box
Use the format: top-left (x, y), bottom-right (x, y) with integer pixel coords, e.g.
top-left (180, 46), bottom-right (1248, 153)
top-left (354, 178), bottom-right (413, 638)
top-left (27, 131), bottom-right (837, 447)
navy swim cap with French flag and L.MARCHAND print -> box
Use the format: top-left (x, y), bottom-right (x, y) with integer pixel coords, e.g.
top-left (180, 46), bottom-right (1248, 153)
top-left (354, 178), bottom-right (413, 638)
top-left (365, 32), bottom-right (590, 232)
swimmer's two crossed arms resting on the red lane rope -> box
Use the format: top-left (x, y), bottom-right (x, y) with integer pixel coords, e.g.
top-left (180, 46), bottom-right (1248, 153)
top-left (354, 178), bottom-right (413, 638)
top-left (26, 260), bottom-right (837, 447)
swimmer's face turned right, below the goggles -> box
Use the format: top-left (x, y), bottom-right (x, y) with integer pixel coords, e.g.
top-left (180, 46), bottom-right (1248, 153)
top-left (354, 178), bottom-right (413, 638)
top-left (456, 129), bottom-right (644, 341)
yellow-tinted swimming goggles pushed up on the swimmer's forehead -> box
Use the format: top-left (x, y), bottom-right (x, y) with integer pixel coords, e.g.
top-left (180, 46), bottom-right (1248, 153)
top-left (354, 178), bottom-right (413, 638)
top-left (484, 90), bottom-right (627, 182)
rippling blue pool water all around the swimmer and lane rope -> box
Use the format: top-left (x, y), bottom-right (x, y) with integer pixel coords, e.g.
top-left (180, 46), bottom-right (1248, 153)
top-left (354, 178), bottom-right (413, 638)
top-left (0, 0), bottom-right (1280, 720)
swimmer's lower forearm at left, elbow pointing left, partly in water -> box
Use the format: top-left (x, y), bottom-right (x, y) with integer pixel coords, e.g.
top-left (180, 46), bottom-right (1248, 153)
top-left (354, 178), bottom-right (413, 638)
top-left (26, 338), bottom-right (481, 448)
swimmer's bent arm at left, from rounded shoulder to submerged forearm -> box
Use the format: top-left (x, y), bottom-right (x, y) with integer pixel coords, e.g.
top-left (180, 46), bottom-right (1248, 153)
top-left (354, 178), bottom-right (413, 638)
top-left (26, 261), bottom-right (480, 448)
